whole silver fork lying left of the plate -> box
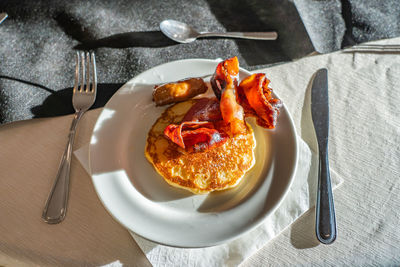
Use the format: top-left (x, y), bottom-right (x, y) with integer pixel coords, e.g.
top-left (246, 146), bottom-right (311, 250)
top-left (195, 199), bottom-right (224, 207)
top-left (42, 52), bottom-right (97, 224)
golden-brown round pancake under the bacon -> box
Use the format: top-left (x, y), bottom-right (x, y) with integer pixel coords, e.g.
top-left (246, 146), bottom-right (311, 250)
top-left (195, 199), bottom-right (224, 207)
top-left (145, 99), bottom-right (256, 194)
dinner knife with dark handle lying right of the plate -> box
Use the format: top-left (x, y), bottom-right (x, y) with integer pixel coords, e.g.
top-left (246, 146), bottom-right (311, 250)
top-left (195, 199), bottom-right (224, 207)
top-left (311, 69), bottom-right (337, 244)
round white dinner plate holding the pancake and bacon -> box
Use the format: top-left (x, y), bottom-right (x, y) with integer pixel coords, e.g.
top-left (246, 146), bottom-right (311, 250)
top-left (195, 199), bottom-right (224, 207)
top-left (89, 59), bottom-right (297, 247)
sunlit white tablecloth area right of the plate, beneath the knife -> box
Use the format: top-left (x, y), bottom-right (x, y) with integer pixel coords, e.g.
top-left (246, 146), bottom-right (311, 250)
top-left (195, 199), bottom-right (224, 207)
top-left (245, 38), bottom-right (400, 266)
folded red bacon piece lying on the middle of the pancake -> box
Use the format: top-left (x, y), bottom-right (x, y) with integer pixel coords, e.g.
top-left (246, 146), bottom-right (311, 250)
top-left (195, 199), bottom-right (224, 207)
top-left (164, 121), bottom-right (228, 152)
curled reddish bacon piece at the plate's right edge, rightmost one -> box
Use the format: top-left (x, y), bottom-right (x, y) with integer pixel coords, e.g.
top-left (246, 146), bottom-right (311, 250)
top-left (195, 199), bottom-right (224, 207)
top-left (238, 73), bottom-right (282, 129)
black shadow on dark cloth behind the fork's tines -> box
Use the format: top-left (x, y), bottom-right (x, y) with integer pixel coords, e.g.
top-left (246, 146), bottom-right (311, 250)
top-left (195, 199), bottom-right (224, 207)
top-left (31, 83), bottom-right (123, 118)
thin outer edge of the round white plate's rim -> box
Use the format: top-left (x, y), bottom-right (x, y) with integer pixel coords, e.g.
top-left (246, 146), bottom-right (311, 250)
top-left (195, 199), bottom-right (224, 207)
top-left (88, 58), bottom-right (299, 248)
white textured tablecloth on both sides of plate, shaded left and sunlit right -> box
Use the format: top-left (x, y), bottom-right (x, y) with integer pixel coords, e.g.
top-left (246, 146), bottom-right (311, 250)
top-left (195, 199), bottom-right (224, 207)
top-left (0, 38), bottom-right (400, 266)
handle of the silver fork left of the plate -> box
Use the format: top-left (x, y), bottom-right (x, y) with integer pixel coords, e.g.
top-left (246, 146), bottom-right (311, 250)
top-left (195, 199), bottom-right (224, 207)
top-left (42, 110), bottom-right (84, 224)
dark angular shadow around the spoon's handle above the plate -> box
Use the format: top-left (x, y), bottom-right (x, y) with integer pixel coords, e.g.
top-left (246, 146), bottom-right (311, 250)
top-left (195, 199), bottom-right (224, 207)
top-left (207, 0), bottom-right (315, 66)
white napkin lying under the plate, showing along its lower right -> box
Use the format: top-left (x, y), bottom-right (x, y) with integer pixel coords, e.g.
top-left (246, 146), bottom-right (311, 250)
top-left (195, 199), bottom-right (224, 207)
top-left (74, 137), bottom-right (343, 267)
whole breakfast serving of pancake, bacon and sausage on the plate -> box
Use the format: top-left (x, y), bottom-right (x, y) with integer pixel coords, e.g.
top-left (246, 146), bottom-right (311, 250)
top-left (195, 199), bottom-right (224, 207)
top-left (145, 57), bottom-right (282, 194)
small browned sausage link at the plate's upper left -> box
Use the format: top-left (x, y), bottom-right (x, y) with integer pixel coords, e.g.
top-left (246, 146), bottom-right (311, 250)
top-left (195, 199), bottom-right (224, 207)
top-left (153, 78), bottom-right (208, 106)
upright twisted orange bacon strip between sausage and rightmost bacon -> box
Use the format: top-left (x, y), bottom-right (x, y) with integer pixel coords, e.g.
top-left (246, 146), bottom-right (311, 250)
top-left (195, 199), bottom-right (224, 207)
top-left (211, 57), bottom-right (247, 135)
